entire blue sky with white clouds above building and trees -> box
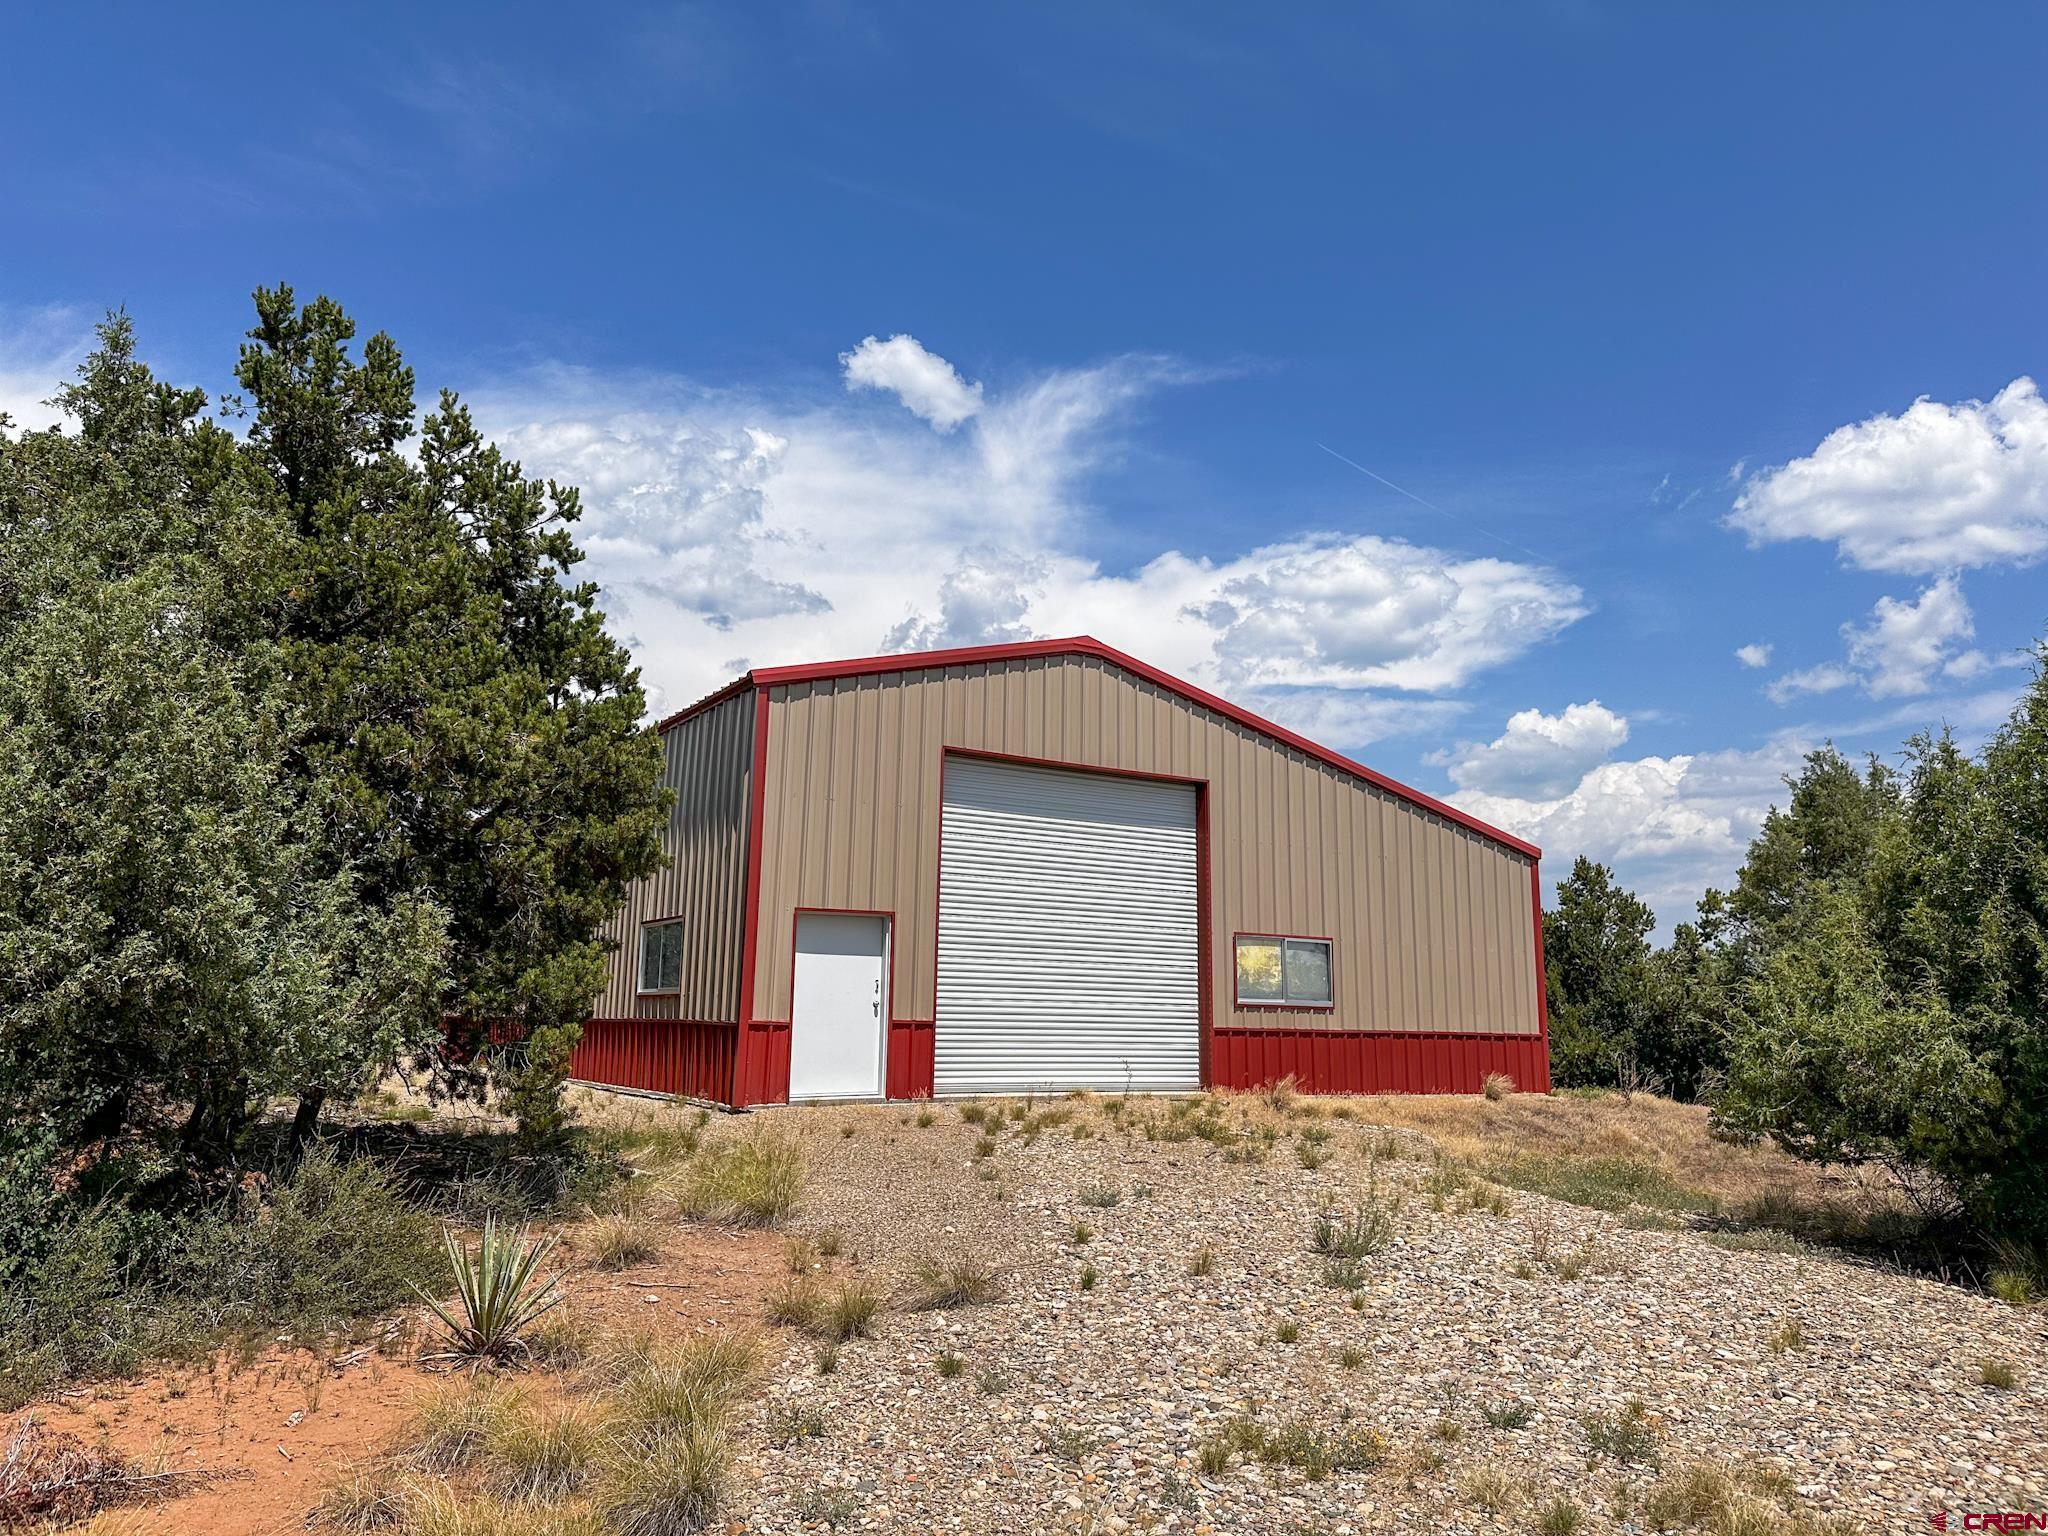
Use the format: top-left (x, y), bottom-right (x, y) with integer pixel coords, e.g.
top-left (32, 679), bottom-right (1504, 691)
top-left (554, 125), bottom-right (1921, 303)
top-left (0, 4), bottom-right (2048, 924)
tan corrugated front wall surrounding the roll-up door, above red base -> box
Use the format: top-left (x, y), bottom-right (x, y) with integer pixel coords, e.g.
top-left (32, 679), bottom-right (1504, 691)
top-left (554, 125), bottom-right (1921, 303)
top-left (754, 657), bottom-right (1538, 1034)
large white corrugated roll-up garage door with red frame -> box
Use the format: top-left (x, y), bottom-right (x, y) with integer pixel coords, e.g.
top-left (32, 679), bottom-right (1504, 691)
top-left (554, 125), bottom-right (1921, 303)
top-left (932, 758), bottom-right (1202, 1094)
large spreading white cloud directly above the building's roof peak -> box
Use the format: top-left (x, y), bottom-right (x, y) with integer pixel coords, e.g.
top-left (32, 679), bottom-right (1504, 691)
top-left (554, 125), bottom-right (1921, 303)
top-left (471, 338), bottom-right (1587, 733)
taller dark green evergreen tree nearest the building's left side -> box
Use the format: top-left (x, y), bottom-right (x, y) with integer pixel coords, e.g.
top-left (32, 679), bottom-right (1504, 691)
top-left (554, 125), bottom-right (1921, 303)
top-left (236, 287), bottom-right (668, 1137)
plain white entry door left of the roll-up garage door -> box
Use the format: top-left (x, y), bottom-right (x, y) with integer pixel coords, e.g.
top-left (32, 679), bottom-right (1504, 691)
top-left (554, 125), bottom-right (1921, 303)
top-left (788, 911), bottom-right (889, 1100)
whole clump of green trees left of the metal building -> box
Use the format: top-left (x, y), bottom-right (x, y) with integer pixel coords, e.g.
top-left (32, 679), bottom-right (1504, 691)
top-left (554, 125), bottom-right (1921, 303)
top-left (0, 289), bottom-right (666, 1182)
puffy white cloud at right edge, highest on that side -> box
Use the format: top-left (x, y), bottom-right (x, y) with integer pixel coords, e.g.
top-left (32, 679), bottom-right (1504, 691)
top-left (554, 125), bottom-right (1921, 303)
top-left (1729, 379), bottom-right (2048, 575)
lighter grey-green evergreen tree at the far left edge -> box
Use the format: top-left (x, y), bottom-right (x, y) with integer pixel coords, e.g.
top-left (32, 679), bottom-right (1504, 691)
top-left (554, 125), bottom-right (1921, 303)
top-left (0, 317), bottom-right (442, 1174)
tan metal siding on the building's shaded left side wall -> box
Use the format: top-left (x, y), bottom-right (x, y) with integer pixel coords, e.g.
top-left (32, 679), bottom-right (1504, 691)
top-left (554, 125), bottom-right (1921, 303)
top-left (592, 690), bottom-right (754, 1024)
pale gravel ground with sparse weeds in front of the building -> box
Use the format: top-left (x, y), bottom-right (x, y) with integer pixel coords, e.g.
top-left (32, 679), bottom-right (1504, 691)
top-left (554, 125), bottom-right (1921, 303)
top-left (717, 1098), bottom-right (2048, 1536)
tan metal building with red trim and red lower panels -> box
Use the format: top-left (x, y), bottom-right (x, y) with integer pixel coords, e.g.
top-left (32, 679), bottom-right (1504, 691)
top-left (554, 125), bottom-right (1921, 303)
top-left (573, 637), bottom-right (1550, 1104)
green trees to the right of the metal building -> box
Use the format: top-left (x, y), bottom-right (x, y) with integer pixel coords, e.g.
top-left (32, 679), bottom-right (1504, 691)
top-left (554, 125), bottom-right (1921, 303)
top-left (1540, 684), bottom-right (2048, 1245)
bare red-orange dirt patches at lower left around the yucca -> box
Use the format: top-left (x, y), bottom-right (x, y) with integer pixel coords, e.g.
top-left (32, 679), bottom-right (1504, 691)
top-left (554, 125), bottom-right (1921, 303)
top-left (0, 1229), bottom-right (782, 1536)
